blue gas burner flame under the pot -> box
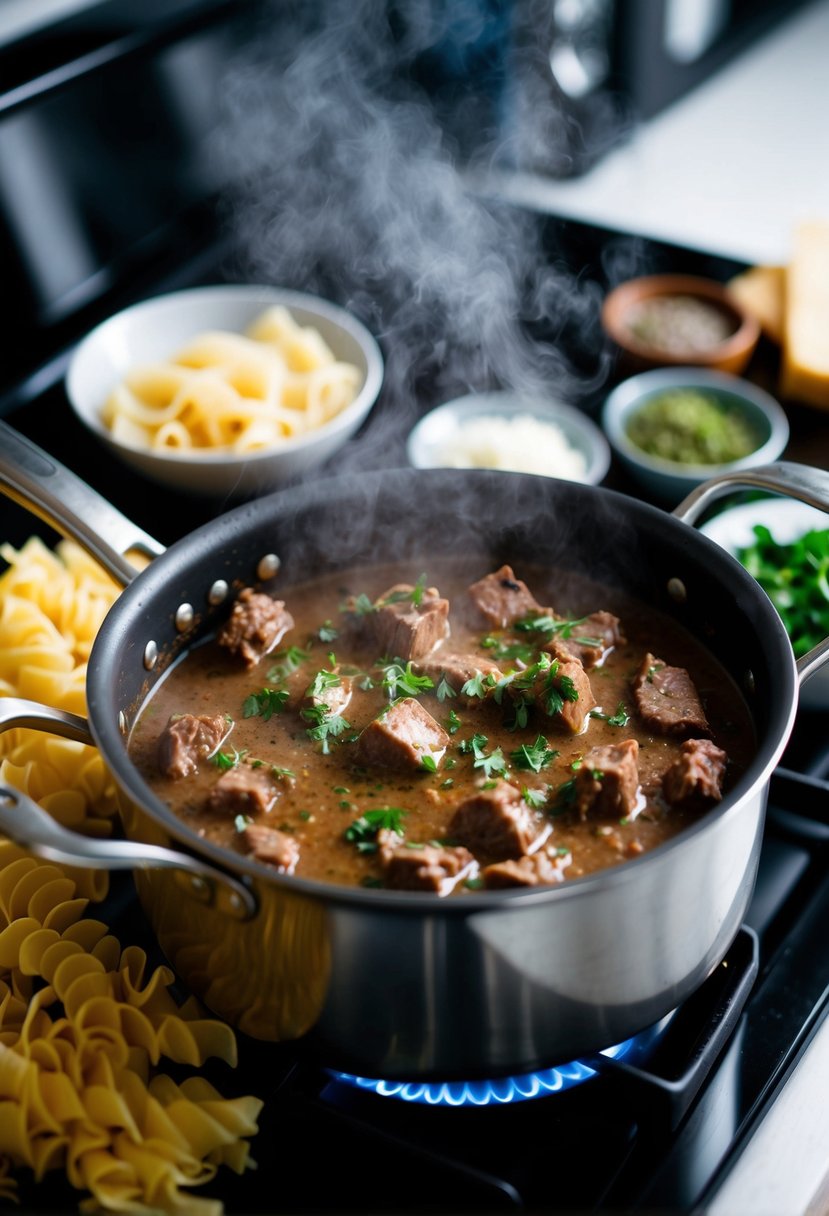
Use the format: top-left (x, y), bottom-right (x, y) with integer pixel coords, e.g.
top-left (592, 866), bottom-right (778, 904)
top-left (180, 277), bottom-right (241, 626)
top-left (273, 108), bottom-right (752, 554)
top-left (331, 1037), bottom-right (638, 1107)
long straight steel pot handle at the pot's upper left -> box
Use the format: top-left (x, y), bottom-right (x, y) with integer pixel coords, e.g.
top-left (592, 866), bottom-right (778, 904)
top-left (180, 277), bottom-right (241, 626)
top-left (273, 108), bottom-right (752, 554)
top-left (0, 421), bottom-right (164, 586)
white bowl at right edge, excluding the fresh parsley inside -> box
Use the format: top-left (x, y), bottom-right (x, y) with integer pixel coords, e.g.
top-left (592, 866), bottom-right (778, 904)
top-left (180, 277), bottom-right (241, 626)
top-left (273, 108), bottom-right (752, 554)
top-left (700, 499), bottom-right (829, 709)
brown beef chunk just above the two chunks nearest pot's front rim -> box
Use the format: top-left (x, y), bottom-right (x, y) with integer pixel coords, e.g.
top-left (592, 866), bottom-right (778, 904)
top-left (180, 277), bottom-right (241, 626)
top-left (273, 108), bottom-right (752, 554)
top-left (449, 781), bottom-right (551, 861)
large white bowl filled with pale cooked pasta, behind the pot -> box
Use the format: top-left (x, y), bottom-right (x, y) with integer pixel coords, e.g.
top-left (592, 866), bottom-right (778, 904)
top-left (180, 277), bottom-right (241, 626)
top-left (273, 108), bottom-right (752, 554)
top-left (66, 283), bottom-right (383, 496)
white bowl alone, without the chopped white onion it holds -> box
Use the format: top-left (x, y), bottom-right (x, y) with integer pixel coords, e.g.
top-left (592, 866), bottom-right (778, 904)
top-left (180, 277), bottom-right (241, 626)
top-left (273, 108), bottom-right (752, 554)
top-left (406, 390), bottom-right (610, 485)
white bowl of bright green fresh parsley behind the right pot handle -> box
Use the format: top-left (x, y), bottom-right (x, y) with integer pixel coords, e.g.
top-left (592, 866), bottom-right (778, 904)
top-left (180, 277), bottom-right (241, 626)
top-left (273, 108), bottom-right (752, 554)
top-left (701, 497), bottom-right (829, 709)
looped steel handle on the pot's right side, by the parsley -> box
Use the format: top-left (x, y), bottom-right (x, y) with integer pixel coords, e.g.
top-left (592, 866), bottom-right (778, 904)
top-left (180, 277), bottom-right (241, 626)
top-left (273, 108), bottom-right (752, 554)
top-left (673, 461), bottom-right (829, 685)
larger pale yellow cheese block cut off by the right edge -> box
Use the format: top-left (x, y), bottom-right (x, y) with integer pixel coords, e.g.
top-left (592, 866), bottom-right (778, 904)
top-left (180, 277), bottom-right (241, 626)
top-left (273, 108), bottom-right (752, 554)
top-left (780, 220), bottom-right (829, 410)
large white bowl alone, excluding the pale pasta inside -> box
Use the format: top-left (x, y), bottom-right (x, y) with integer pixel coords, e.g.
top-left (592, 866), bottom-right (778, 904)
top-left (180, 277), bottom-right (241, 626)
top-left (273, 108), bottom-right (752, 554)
top-left (66, 285), bottom-right (383, 496)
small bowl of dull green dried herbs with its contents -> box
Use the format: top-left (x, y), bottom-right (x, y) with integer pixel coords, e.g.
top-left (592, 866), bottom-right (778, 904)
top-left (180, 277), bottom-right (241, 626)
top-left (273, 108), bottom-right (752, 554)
top-left (602, 367), bottom-right (789, 506)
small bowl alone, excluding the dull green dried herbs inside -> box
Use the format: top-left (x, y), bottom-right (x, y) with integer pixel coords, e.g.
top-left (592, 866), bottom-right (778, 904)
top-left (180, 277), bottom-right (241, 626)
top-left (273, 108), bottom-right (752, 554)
top-left (602, 367), bottom-right (789, 507)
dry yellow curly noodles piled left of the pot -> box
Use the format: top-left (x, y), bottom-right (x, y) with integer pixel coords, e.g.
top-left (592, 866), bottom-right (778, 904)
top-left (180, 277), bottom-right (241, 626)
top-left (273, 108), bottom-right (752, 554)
top-left (0, 540), bottom-right (261, 1216)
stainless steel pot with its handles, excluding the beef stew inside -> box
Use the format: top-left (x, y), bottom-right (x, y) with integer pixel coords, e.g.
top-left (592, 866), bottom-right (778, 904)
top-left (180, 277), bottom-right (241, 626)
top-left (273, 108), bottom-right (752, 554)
top-left (0, 424), bottom-right (829, 1080)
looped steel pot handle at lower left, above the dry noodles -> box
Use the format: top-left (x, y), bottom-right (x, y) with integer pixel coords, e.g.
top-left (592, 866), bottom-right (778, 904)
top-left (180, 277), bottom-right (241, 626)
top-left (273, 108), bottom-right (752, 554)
top-left (0, 697), bottom-right (258, 921)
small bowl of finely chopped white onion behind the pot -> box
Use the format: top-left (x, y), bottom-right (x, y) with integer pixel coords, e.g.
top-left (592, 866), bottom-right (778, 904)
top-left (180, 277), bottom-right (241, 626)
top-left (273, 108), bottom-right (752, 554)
top-left (406, 390), bottom-right (610, 485)
